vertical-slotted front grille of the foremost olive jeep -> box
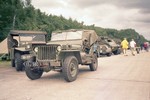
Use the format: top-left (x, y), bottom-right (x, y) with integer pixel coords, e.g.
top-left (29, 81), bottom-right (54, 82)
top-left (37, 45), bottom-right (58, 60)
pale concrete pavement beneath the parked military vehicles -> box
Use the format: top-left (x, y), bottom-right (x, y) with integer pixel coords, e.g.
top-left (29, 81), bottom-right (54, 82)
top-left (0, 52), bottom-right (150, 100)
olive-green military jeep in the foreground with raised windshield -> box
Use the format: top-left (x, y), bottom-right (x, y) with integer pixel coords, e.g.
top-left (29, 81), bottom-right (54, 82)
top-left (23, 29), bottom-right (98, 82)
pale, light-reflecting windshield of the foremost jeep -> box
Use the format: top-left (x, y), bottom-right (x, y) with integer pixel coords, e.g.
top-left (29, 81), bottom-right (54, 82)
top-left (51, 31), bottom-right (82, 41)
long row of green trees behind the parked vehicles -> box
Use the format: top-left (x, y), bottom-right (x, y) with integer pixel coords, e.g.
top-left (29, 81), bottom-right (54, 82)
top-left (0, 0), bottom-right (147, 43)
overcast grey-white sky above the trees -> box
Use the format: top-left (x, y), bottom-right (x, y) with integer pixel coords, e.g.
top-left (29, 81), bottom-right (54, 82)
top-left (32, 0), bottom-right (150, 40)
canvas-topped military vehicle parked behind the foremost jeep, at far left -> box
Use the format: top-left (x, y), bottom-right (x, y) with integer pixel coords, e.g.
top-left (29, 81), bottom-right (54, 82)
top-left (7, 30), bottom-right (47, 71)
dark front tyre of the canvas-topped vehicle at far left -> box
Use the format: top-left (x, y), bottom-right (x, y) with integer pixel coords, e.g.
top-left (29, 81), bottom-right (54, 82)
top-left (15, 53), bottom-right (24, 71)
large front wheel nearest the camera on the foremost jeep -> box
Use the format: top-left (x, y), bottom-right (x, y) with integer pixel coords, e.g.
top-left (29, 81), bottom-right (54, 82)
top-left (62, 56), bottom-right (78, 82)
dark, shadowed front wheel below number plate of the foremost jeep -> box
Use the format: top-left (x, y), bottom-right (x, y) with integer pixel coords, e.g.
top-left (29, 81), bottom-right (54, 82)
top-left (25, 60), bottom-right (43, 80)
